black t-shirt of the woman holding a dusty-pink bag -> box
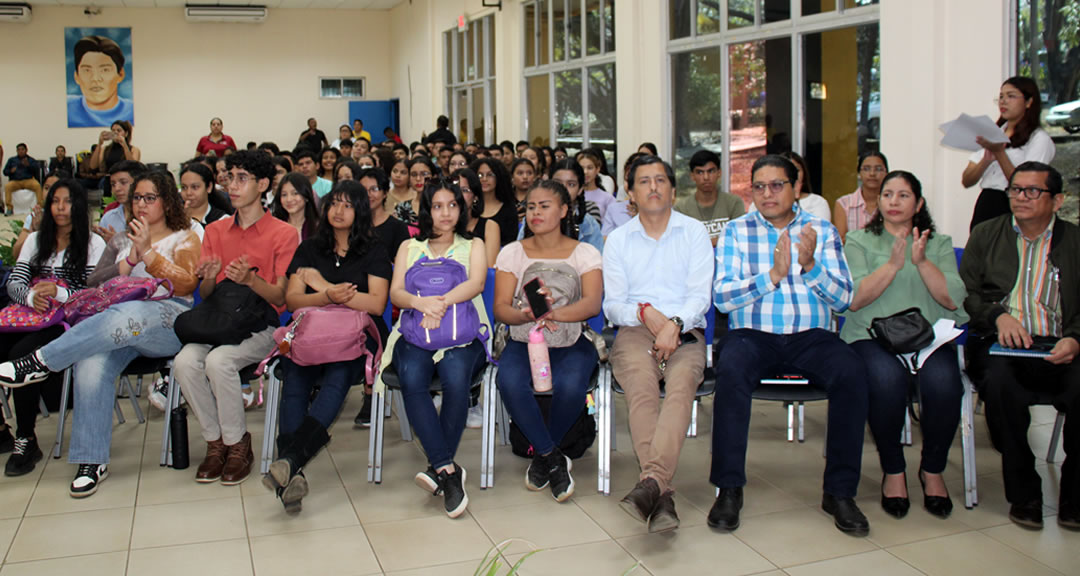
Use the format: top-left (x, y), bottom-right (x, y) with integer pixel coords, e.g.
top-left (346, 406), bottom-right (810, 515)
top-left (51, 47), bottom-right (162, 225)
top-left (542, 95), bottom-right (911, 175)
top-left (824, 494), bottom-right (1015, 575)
top-left (286, 238), bottom-right (393, 341)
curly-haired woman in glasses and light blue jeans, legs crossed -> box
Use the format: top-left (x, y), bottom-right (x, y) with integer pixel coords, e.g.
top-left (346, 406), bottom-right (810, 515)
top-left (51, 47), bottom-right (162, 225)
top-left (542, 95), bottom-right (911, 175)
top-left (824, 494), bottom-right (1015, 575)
top-left (0, 171), bottom-right (200, 498)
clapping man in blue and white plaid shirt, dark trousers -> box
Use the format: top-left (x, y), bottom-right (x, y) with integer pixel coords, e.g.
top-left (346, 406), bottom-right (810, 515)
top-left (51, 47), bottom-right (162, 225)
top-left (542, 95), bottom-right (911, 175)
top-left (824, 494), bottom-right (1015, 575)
top-left (708, 156), bottom-right (869, 536)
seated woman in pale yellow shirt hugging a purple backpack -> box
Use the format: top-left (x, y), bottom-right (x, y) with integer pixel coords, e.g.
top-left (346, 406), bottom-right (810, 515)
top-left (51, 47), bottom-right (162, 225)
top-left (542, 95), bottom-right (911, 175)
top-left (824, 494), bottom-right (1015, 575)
top-left (382, 178), bottom-right (490, 518)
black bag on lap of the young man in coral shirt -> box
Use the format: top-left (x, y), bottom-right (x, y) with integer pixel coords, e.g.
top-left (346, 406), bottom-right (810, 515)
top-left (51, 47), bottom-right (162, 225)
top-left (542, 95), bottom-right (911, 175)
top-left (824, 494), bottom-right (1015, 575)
top-left (173, 280), bottom-right (280, 346)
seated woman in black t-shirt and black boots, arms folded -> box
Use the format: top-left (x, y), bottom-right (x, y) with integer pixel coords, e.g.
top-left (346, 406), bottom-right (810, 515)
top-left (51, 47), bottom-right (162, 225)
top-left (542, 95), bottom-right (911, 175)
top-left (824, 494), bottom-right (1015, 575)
top-left (264, 179), bottom-right (391, 512)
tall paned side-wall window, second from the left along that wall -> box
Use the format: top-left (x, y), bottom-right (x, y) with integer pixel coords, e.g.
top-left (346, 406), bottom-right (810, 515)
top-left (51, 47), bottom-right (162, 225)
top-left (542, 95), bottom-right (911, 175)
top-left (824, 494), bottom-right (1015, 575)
top-left (523, 0), bottom-right (617, 162)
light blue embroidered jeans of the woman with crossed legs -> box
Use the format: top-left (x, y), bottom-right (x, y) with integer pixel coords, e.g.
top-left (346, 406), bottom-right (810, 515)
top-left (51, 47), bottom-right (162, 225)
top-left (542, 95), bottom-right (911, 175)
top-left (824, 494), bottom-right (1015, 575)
top-left (34, 299), bottom-right (189, 464)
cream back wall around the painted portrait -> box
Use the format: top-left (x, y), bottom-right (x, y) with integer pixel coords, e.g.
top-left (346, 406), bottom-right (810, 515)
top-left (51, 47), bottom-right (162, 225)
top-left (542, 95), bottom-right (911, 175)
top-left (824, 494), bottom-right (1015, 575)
top-left (0, 6), bottom-right (395, 169)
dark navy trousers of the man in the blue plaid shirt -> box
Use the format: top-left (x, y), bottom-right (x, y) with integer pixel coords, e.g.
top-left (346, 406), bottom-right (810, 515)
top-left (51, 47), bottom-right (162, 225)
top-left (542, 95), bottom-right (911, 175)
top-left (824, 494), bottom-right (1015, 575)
top-left (710, 329), bottom-right (872, 498)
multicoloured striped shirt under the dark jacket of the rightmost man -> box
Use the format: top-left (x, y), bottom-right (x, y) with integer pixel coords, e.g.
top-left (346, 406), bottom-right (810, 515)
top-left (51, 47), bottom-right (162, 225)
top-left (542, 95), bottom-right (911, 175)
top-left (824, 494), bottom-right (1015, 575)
top-left (1003, 217), bottom-right (1062, 337)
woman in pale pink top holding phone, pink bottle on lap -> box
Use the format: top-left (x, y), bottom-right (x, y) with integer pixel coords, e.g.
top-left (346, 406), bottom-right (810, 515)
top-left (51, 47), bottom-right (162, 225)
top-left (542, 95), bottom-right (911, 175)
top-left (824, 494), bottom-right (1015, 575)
top-left (494, 180), bottom-right (604, 501)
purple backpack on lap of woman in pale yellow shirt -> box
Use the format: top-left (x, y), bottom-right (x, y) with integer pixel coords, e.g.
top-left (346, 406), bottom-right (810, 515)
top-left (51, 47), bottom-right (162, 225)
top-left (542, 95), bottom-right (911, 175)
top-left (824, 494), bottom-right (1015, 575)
top-left (397, 256), bottom-right (487, 350)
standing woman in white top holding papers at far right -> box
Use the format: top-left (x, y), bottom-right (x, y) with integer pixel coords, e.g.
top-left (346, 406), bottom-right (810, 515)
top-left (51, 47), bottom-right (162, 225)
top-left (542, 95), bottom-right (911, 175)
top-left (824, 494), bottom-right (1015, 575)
top-left (961, 76), bottom-right (1055, 229)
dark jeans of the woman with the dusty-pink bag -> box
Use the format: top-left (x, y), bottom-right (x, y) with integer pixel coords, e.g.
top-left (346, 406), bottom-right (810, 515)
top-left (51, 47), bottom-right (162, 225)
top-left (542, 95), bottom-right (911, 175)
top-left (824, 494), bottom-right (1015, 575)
top-left (279, 357), bottom-right (367, 436)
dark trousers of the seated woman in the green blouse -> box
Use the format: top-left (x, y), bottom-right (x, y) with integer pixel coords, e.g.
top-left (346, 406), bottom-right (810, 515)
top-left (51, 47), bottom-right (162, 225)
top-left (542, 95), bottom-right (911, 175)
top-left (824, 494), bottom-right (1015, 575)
top-left (851, 340), bottom-right (963, 474)
